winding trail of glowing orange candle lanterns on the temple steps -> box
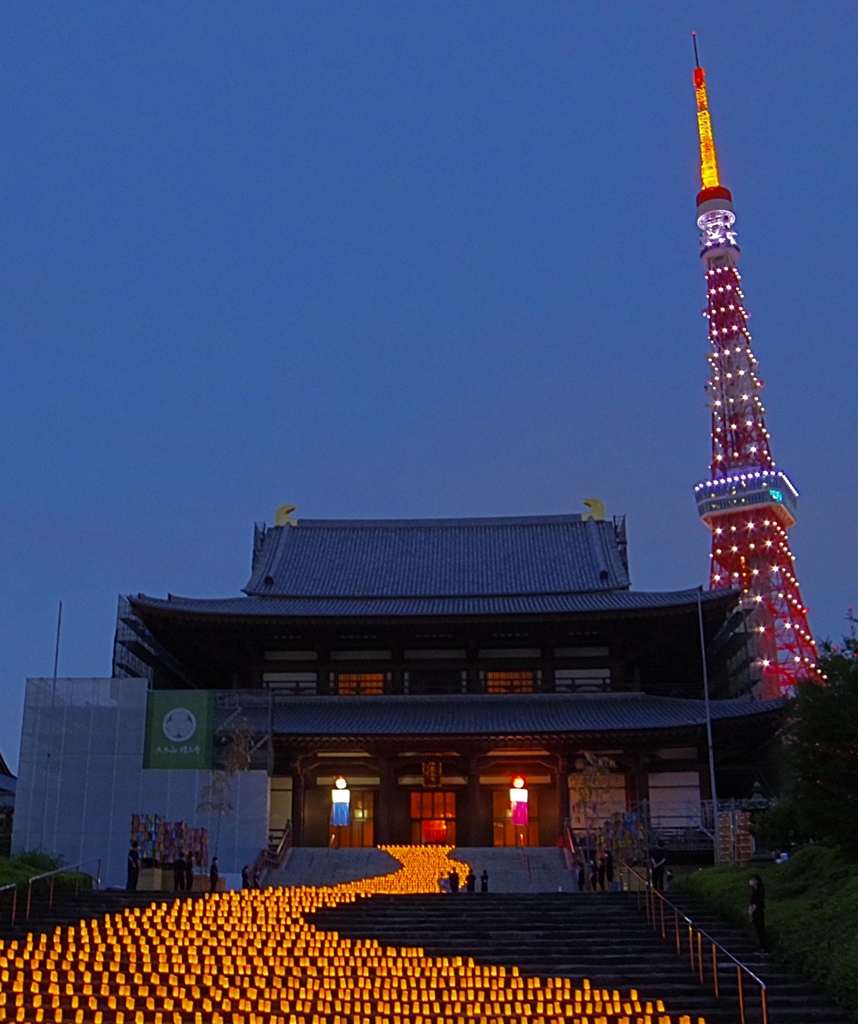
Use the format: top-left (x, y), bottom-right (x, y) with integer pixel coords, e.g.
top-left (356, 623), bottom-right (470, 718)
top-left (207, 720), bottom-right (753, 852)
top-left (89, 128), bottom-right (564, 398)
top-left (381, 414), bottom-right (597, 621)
top-left (0, 846), bottom-right (704, 1024)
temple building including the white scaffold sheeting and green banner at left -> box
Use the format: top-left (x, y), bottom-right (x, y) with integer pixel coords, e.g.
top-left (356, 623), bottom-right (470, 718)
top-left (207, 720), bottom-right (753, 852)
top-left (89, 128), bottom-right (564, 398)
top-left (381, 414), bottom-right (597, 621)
top-left (14, 502), bottom-right (781, 881)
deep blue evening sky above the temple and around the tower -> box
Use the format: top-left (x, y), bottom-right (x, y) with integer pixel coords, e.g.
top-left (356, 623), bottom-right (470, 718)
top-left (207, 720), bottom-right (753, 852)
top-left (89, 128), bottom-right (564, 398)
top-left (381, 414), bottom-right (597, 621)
top-left (0, 0), bottom-right (858, 765)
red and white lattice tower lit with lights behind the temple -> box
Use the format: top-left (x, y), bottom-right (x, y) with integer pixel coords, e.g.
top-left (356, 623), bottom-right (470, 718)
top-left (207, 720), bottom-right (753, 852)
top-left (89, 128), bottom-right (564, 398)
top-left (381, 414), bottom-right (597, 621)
top-left (694, 39), bottom-right (819, 697)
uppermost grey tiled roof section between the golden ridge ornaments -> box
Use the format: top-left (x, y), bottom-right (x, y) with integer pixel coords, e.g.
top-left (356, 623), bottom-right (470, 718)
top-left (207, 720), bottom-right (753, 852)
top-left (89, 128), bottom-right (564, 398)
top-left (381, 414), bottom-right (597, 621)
top-left (245, 515), bottom-right (629, 598)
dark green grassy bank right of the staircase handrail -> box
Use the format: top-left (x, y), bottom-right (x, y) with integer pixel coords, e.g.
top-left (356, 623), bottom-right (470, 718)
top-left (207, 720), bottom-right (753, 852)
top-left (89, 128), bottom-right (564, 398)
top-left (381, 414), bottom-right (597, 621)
top-left (674, 847), bottom-right (858, 1020)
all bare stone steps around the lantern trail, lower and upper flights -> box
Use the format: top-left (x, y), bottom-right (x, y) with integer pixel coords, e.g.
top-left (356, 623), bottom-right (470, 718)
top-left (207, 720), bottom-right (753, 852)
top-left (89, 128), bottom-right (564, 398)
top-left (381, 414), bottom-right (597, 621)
top-left (0, 849), bottom-right (849, 1024)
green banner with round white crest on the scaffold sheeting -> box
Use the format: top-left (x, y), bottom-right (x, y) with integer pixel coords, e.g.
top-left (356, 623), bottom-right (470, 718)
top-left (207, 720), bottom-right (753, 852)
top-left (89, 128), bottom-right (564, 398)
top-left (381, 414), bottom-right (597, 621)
top-left (143, 690), bottom-right (215, 768)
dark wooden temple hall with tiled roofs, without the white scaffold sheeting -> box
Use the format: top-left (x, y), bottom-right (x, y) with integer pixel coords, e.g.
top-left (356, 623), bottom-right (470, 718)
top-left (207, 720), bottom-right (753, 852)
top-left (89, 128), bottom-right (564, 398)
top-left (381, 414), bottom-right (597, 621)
top-left (114, 515), bottom-right (780, 846)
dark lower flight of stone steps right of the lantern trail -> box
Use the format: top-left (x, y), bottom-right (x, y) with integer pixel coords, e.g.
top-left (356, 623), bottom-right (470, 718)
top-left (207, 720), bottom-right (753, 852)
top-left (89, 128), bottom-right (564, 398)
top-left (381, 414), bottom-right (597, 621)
top-left (310, 888), bottom-right (849, 1024)
